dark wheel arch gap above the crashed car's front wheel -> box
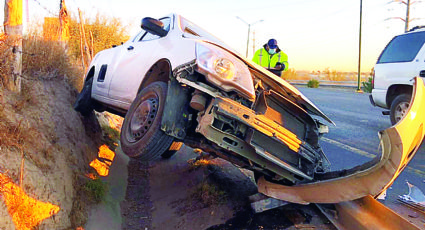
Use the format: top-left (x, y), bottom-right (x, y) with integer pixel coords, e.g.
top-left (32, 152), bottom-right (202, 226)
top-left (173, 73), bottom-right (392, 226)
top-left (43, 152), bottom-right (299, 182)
top-left (137, 59), bottom-right (171, 93)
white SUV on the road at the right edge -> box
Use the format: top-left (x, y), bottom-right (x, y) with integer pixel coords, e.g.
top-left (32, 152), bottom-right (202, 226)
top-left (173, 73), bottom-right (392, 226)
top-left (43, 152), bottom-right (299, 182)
top-left (369, 25), bottom-right (425, 125)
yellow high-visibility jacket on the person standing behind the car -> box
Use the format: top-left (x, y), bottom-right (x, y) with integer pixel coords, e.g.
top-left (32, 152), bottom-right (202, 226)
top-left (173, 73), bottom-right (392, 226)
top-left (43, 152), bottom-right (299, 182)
top-left (252, 47), bottom-right (288, 71)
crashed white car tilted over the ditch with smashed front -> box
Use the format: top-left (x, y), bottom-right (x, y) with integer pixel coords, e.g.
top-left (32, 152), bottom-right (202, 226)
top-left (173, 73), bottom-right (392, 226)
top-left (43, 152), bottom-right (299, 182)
top-left (75, 14), bottom-right (424, 203)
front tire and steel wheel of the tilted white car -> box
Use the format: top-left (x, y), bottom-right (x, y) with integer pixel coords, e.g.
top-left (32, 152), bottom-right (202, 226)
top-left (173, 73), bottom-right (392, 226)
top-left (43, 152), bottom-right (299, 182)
top-left (120, 82), bottom-right (174, 161)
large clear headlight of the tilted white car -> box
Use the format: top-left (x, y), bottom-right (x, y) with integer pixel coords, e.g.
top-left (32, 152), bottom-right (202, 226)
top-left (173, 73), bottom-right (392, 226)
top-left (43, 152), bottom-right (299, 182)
top-left (196, 43), bottom-right (255, 100)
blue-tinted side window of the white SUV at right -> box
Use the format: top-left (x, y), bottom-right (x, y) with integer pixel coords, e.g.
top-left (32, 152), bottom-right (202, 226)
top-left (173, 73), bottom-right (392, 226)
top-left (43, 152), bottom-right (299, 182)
top-left (378, 31), bottom-right (425, 63)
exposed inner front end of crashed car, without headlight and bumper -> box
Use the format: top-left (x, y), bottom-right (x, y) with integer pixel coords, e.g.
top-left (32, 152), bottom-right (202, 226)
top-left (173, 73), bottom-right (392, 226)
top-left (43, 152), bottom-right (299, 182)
top-left (162, 57), bottom-right (329, 185)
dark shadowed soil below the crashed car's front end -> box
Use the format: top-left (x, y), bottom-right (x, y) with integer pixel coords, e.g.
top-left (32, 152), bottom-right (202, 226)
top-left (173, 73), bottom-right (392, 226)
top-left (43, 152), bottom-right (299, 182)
top-left (117, 145), bottom-right (335, 230)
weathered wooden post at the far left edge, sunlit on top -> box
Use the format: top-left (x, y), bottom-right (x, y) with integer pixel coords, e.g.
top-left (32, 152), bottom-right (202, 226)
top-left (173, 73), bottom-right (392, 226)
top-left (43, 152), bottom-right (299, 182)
top-left (4, 0), bottom-right (23, 92)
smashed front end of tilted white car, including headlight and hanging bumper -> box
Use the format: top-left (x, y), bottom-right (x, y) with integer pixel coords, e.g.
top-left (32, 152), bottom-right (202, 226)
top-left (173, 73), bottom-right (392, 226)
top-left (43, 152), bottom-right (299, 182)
top-left (161, 42), bottom-right (425, 204)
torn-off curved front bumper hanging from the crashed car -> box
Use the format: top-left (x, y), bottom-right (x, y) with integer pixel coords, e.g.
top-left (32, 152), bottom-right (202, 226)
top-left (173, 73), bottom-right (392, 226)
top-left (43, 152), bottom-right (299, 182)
top-left (258, 77), bottom-right (425, 204)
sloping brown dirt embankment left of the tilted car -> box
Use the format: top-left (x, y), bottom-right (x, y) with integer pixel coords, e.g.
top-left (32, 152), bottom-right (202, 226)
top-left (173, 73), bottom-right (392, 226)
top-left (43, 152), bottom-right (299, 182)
top-left (0, 78), bottom-right (111, 229)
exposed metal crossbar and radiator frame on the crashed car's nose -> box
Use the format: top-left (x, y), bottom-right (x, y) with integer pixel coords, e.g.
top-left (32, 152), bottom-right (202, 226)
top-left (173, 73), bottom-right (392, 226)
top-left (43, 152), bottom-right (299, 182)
top-left (196, 96), bottom-right (323, 183)
